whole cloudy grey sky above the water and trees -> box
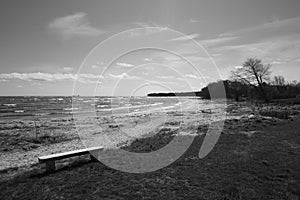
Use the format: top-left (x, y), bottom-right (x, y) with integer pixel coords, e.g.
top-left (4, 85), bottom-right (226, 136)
top-left (0, 0), bottom-right (300, 96)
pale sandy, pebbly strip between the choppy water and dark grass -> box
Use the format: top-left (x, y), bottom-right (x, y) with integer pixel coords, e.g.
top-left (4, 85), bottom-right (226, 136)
top-left (0, 101), bottom-right (227, 173)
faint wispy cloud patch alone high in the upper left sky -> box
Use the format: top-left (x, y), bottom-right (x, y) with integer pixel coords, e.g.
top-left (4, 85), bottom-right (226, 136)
top-left (49, 12), bottom-right (104, 38)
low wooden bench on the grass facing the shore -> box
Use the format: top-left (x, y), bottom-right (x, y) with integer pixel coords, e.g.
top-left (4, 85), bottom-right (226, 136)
top-left (38, 147), bottom-right (103, 172)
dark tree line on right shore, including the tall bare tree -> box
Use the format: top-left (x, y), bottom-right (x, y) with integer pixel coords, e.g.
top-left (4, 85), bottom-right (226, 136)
top-left (201, 58), bottom-right (300, 102)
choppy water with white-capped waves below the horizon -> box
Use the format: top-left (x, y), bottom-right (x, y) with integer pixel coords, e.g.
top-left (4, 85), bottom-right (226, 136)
top-left (0, 96), bottom-right (199, 119)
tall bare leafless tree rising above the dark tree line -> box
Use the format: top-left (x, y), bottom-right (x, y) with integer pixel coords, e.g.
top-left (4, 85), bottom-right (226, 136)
top-left (231, 58), bottom-right (271, 101)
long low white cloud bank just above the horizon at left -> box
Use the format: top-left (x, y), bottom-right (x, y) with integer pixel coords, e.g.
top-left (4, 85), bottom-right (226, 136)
top-left (0, 72), bottom-right (101, 83)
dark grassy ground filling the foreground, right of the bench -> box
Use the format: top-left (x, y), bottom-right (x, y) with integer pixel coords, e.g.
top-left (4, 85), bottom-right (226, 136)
top-left (0, 102), bottom-right (300, 200)
